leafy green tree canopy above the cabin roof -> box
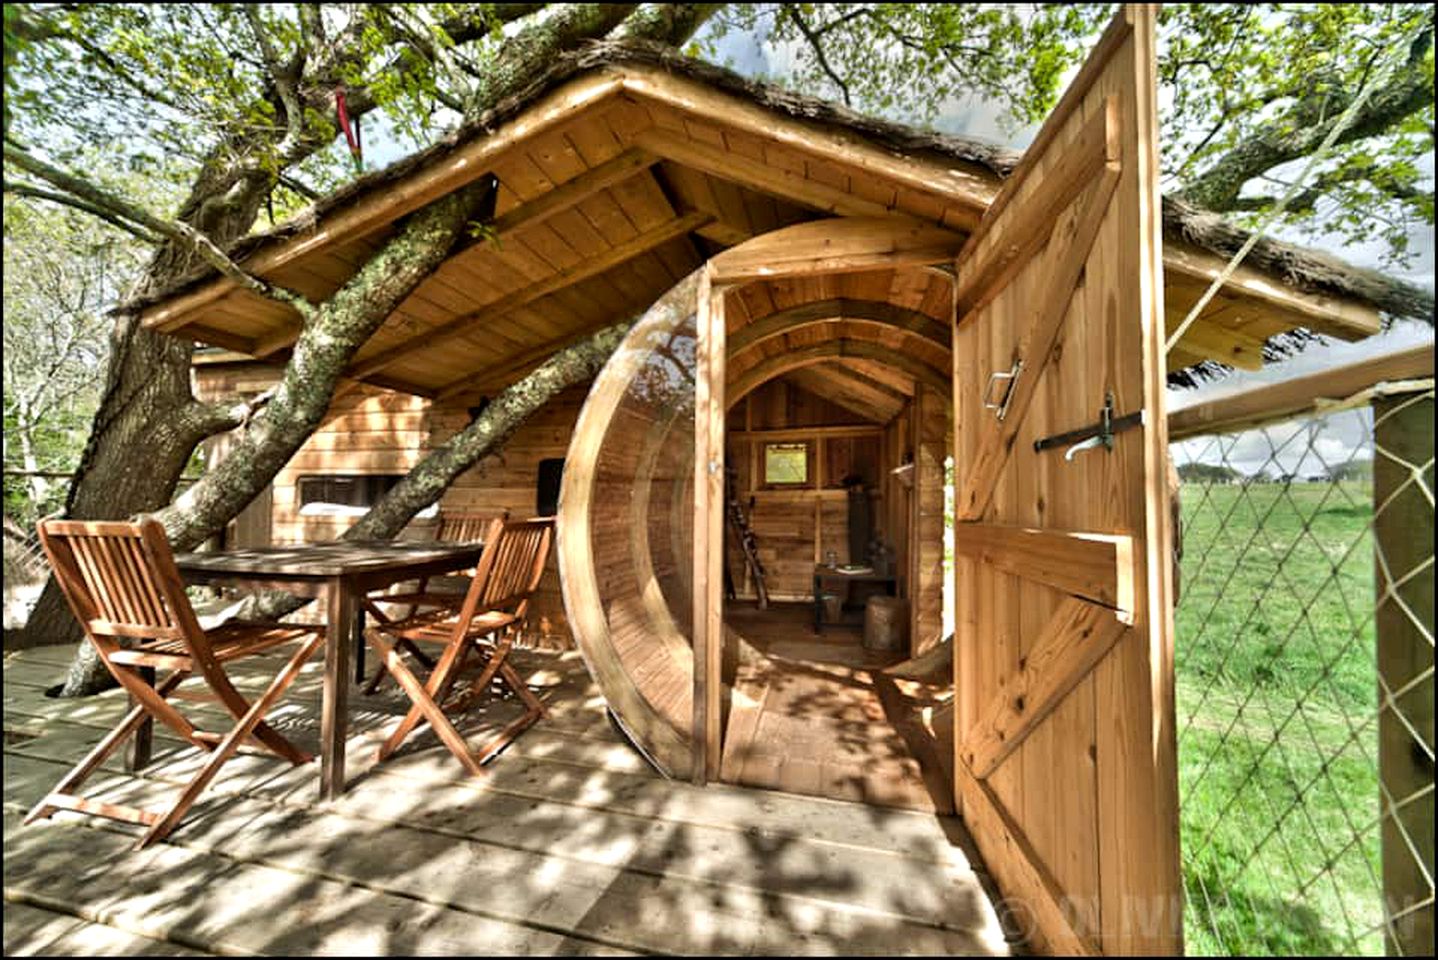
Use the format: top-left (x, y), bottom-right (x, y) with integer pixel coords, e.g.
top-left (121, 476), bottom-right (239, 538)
top-left (6, 3), bottom-right (1434, 262)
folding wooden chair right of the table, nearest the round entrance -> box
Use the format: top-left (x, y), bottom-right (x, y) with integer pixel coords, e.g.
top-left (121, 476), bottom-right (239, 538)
top-left (365, 519), bottom-right (554, 776)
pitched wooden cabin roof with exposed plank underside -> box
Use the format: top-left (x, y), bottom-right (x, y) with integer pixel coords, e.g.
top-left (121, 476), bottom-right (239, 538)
top-left (140, 43), bottom-right (1397, 398)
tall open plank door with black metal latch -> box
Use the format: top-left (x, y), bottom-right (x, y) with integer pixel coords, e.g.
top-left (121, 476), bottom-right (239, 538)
top-left (953, 7), bottom-right (1182, 954)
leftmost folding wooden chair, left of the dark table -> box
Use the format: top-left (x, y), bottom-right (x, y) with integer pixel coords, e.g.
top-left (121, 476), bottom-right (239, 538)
top-left (24, 517), bottom-right (325, 848)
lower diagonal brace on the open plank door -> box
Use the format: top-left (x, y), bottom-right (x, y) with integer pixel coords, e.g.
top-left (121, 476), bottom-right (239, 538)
top-left (959, 596), bottom-right (1127, 780)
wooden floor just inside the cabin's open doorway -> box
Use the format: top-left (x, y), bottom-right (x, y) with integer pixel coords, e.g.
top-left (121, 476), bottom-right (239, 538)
top-left (720, 602), bottom-right (953, 813)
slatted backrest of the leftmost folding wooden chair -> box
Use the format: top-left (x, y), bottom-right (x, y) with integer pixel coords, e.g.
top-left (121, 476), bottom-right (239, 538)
top-left (37, 517), bottom-right (200, 642)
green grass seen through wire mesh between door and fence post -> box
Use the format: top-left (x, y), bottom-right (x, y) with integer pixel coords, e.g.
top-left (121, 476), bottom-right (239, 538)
top-left (1176, 481), bottom-right (1383, 954)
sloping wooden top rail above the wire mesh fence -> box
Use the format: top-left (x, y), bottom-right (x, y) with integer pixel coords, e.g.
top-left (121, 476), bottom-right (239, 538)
top-left (1168, 343), bottom-right (1434, 440)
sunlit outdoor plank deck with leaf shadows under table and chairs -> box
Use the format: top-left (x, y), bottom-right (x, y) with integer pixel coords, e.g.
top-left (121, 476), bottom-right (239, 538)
top-left (4, 647), bottom-right (1009, 956)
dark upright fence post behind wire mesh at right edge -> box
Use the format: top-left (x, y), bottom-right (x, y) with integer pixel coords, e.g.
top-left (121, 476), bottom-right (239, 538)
top-left (1373, 388), bottom-right (1434, 956)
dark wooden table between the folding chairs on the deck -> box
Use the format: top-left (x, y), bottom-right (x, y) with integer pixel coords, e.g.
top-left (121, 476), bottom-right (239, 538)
top-left (175, 540), bottom-right (483, 800)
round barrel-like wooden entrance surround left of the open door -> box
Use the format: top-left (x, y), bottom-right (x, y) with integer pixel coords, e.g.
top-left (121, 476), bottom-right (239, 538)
top-left (559, 218), bottom-right (962, 780)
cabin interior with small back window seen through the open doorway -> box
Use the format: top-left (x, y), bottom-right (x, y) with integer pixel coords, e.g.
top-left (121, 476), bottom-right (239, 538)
top-left (719, 267), bottom-right (953, 812)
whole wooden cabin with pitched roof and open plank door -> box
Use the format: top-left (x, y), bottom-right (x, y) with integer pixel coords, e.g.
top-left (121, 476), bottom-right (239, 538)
top-left (142, 9), bottom-right (1414, 953)
